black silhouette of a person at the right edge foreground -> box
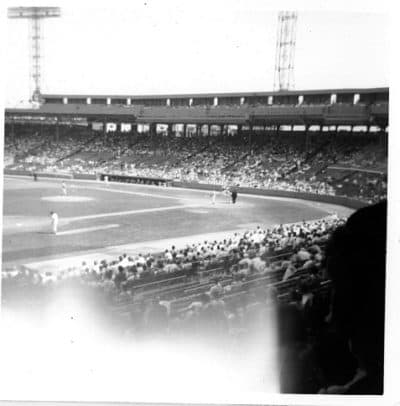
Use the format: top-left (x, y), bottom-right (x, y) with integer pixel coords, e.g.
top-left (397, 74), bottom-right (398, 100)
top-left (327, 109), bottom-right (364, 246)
top-left (321, 201), bottom-right (387, 394)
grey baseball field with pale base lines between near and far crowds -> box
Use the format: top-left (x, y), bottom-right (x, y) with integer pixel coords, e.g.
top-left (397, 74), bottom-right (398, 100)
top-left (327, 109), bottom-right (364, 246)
top-left (2, 176), bottom-right (351, 266)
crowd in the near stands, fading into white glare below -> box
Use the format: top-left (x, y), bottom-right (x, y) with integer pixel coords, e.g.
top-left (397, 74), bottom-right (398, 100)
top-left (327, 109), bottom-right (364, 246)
top-left (2, 215), bottom-right (344, 364)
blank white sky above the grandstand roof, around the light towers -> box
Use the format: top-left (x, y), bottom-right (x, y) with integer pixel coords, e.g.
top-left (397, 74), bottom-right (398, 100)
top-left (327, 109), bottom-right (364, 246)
top-left (5, 0), bottom-right (388, 105)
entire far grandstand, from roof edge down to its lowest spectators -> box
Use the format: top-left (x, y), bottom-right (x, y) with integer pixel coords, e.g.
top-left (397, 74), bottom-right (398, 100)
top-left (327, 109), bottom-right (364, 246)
top-left (6, 89), bottom-right (389, 202)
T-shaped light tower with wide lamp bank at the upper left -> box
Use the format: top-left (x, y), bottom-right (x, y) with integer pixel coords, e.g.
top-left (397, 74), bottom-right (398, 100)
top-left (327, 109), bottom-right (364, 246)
top-left (8, 7), bottom-right (61, 102)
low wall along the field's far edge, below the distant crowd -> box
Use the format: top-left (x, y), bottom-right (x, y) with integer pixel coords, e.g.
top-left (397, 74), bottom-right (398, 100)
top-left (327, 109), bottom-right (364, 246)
top-left (4, 169), bottom-right (366, 209)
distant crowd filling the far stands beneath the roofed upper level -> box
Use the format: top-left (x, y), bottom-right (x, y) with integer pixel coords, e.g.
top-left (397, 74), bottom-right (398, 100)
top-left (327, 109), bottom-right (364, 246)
top-left (5, 123), bottom-right (387, 203)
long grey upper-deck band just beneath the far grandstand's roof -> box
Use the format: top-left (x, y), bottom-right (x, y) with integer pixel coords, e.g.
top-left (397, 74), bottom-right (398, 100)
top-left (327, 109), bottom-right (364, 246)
top-left (6, 105), bottom-right (388, 127)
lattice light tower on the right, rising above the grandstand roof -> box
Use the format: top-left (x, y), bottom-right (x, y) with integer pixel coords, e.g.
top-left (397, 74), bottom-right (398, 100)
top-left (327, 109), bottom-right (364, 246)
top-left (274, 11), bottom-right (297, 90)
